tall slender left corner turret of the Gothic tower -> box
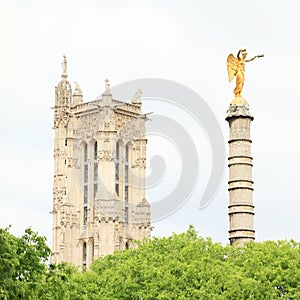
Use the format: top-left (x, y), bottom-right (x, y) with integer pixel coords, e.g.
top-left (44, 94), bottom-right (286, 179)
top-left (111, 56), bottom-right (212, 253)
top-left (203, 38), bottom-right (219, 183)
top-left (51, 55), bottom-right (75, 262)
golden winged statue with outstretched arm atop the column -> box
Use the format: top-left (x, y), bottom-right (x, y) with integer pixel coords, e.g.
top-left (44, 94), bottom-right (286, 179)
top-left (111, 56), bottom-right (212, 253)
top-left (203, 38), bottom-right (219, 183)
top-left (227, 49), bottom-right (264, 98)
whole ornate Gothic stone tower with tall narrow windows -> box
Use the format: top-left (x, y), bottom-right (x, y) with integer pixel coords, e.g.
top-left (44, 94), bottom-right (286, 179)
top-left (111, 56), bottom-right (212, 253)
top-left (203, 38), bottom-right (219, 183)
top-left (51, 56), bottom-right (151, 267)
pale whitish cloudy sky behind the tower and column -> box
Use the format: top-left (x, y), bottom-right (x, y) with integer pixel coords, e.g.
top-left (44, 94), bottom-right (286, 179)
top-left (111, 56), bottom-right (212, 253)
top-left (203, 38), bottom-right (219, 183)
top-left (0, 0), bottom-right (300, 245)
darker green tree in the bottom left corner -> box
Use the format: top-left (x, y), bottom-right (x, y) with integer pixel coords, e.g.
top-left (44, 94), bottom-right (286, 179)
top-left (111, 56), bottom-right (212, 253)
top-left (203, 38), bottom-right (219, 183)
top-left (0, 228), bottom-right (50, 300)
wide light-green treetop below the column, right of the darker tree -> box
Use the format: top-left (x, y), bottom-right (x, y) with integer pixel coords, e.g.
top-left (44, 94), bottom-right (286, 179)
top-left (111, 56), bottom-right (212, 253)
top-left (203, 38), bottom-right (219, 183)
top-left (70, 227), bottom-right (300, 299)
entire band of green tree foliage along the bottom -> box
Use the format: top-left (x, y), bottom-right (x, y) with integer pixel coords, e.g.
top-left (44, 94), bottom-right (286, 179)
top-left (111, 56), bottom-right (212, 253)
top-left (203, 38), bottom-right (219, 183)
top-left (0, 227), bottom-right (300, 300)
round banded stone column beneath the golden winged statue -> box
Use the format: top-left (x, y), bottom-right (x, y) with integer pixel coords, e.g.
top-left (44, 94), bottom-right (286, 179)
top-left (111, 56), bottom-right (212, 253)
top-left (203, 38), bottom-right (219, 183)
top-left (226, 97), bottom-right (254, 246)
